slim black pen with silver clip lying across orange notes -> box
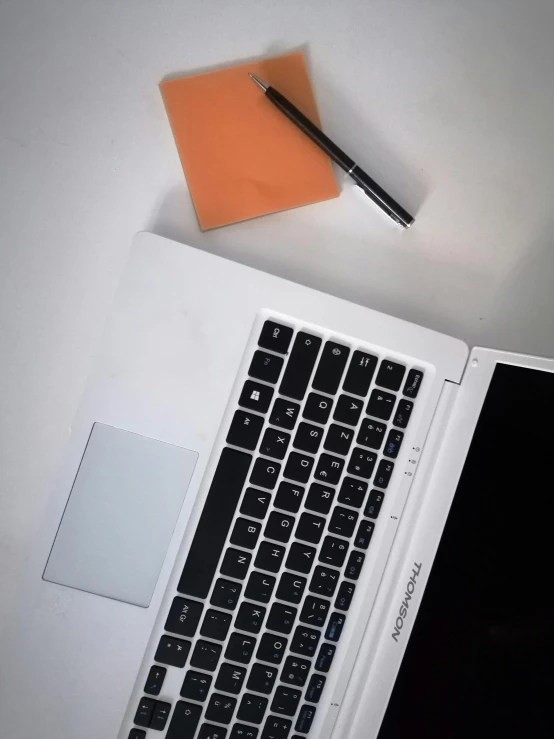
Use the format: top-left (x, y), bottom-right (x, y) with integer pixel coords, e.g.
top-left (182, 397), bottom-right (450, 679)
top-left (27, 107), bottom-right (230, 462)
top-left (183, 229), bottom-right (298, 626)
top-left (249, 73), bottom-right (414, 228)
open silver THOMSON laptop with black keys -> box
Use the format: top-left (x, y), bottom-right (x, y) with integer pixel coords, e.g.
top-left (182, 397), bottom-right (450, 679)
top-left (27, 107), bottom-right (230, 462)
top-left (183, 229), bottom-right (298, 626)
top-left (0, 233), bottom-right (554, 739)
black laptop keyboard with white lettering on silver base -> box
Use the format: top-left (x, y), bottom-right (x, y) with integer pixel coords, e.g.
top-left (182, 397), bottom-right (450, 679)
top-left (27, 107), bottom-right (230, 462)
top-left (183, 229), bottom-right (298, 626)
top-left (129, 320), bottom-right (423, 739)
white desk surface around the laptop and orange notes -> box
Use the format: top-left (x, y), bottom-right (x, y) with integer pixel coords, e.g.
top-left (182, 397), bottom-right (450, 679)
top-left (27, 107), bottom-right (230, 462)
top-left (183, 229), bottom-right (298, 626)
top-left (0, 0), bottom-right (554, 618)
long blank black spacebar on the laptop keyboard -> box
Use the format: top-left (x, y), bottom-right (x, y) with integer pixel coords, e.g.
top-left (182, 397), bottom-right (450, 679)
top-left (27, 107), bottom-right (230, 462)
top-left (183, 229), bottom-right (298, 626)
top-left (177, 447), bottom-right (252, 598)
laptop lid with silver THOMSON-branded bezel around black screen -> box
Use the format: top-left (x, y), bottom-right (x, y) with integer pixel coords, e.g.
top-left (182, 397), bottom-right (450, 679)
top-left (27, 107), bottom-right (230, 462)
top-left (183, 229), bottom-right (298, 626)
top-left (344, 349), bottom-right (554, 739)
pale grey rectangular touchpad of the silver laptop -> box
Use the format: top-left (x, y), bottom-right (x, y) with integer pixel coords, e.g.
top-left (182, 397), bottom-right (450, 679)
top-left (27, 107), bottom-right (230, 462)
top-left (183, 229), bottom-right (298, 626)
top-left (44, 423), bottom-right (198, 607)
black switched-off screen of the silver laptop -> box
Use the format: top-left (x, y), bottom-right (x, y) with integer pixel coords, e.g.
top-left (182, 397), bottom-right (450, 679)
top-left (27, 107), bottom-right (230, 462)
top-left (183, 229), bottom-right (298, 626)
top-left (379, 364), bottom-right (554, 739)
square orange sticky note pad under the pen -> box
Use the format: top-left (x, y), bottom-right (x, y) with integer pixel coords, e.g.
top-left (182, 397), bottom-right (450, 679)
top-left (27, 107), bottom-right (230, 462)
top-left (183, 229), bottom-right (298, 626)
top-left (160, 52), bottom-right (339, 229)
